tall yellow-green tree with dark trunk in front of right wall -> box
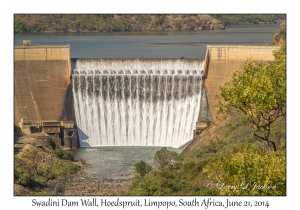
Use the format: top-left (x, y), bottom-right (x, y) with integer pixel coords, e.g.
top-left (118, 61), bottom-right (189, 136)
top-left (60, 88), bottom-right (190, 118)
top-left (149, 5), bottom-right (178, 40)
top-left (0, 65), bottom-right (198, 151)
top-left (217, 49), bottom-right (286, 151)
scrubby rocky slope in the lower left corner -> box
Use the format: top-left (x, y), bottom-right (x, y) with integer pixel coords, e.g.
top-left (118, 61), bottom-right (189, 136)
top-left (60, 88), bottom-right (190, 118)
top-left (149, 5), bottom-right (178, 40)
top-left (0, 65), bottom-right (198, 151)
top-left (14, 145), bottom-right (79, 195)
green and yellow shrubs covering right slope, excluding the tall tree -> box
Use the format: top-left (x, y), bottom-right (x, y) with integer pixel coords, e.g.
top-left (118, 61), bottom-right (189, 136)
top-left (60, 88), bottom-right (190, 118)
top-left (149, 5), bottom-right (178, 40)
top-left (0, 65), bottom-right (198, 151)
top-left (124, 110), bottom-right (286, 196)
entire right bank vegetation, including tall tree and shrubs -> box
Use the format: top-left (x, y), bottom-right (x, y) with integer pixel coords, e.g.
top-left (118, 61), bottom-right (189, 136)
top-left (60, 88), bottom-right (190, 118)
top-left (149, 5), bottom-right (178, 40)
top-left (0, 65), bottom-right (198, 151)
top-left (125, 35), bottom-right (286, 196)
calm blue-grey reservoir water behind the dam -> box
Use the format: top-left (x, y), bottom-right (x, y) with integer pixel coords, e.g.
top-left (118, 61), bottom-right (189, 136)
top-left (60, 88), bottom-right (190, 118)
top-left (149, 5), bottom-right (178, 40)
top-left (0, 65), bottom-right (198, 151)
top-left (14, 23), bottom-right (280, 58)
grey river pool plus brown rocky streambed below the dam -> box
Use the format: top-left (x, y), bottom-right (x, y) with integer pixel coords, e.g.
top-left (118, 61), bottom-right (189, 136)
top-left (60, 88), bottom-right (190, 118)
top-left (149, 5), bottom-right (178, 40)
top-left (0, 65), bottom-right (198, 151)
top-left (47, 146), bottom-right (182, 196)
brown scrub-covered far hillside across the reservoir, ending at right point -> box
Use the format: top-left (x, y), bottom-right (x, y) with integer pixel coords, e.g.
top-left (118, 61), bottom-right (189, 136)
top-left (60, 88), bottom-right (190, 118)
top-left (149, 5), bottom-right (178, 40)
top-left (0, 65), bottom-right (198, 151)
top-left (14, 14), bottom-right (224, 33)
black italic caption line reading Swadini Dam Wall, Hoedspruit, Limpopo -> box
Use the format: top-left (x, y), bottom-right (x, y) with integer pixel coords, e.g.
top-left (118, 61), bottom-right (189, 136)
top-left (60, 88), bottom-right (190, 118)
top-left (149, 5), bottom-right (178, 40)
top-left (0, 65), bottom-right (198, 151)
top-left (31, 198), bottom-right (270, 209)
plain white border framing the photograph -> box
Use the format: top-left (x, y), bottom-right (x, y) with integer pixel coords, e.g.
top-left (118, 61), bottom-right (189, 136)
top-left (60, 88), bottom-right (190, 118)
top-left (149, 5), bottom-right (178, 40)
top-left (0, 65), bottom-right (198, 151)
top-left (0, 0), bottom-right (300, 209)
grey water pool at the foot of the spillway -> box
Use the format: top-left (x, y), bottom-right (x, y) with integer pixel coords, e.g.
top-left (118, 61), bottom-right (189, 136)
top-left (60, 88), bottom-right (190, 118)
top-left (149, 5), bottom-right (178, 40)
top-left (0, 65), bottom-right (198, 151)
top-left (74, 146), bottom-right (181, 179)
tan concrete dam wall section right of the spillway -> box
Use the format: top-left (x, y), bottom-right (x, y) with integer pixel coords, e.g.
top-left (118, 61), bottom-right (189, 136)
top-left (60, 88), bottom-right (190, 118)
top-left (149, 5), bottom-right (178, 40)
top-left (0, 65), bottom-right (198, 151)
top-left (204, 45), bottom-right (280, 117)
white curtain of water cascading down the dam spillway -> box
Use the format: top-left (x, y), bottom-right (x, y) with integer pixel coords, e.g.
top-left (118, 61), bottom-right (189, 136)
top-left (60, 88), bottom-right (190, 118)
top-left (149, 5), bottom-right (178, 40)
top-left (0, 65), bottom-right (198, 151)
top-left (72, 59), bottom-right (203, 148)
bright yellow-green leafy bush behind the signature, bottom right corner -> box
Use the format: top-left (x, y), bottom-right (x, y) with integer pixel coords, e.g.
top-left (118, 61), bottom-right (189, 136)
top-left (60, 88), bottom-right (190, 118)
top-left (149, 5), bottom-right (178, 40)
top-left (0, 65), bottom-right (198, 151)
top-left (203, 148), bottom-right (286, 196)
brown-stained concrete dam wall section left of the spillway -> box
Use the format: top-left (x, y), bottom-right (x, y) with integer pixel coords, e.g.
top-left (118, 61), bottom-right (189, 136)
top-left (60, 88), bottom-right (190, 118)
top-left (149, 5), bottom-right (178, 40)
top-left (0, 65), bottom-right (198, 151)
top-left (14, 45), bottom-right (74, 125)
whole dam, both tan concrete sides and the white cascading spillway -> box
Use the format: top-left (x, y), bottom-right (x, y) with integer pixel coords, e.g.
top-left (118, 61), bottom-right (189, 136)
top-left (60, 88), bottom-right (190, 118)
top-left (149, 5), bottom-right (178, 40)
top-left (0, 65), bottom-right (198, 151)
top-left (14, 45), bottom-right (279, 147)
